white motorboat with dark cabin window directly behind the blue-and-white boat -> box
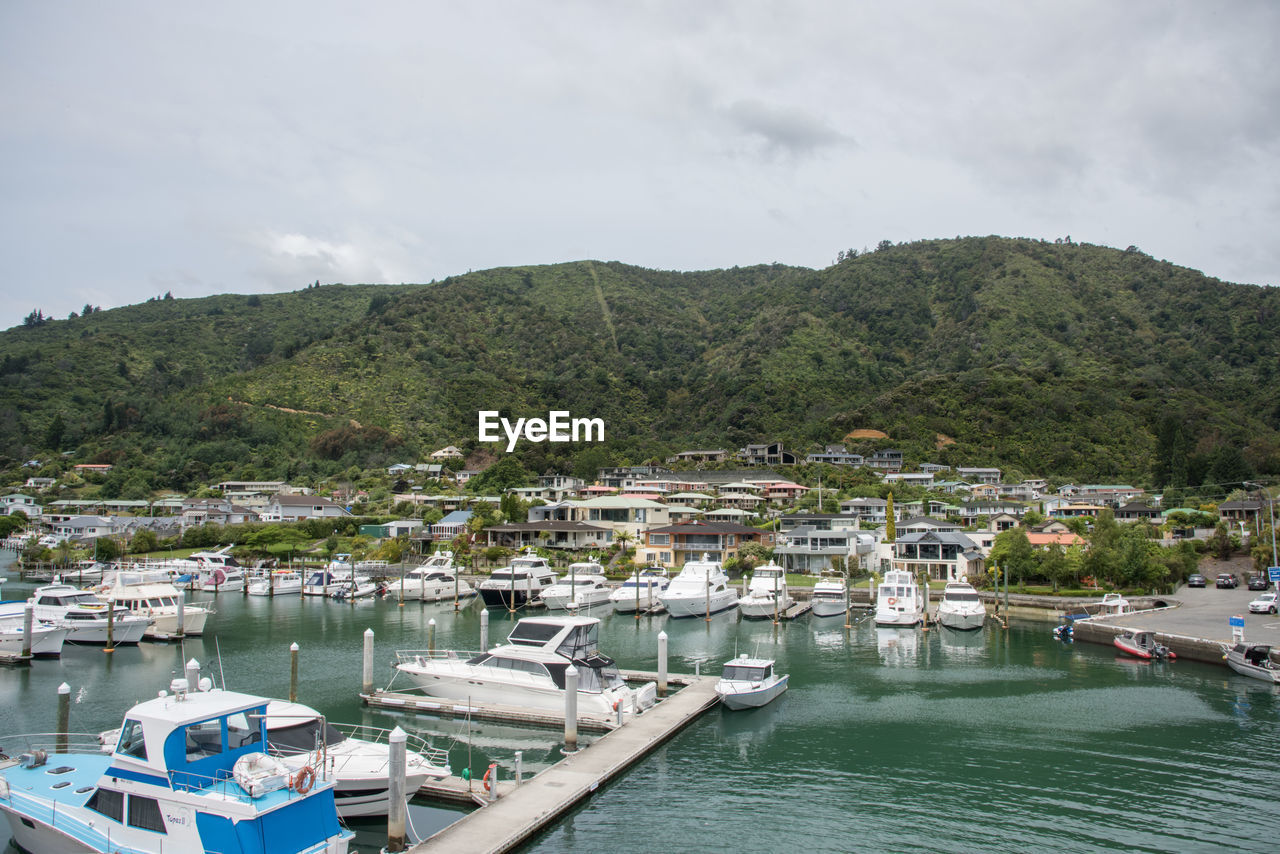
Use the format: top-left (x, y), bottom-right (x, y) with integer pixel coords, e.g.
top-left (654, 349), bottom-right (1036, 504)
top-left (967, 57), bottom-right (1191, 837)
top-left (266, 700), bottom-right (449, 818)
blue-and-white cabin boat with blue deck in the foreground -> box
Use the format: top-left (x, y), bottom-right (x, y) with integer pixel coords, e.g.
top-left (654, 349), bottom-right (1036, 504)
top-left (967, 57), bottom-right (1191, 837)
top-left (0, 679), bottom-right (353, 854)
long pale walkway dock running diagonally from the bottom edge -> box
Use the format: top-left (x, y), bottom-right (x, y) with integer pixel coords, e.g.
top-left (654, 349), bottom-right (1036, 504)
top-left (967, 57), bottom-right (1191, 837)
top-left (408, 675), bottom-right (719, 854)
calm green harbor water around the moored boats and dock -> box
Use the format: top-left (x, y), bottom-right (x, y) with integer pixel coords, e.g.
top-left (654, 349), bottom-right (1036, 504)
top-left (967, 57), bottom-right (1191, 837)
top-left (0, 558), bottom-right (1280, 853)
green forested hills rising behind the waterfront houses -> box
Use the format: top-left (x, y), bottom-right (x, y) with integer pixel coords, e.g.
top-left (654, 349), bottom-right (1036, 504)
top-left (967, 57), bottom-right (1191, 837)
top-left (0, 237), bottom-right (1280, 492)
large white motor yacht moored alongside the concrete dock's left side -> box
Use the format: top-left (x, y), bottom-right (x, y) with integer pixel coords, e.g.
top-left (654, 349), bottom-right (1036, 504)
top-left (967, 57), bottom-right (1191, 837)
top-left (396, 616), bottom-right (657, 720)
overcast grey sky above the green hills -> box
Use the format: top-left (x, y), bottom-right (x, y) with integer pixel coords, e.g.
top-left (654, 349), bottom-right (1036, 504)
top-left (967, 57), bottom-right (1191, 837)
top-left (0, 0), bottom-right (1280, 328)
